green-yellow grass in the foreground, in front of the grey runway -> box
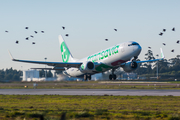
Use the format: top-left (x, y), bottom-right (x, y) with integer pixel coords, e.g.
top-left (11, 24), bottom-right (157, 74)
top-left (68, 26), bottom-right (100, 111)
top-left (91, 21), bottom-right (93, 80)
top-left (0, 95), bottom-right (180, 120)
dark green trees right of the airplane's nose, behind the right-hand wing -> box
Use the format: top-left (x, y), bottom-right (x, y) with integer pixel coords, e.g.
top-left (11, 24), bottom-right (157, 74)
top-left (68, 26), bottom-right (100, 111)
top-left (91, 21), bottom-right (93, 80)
top-left (134, 50), bottom-right (180, 78)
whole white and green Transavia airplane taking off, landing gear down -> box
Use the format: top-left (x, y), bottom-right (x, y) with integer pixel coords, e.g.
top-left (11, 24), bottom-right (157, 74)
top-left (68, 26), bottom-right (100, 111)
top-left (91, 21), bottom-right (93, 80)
top-left (9, 35), bottom-right (164, 80)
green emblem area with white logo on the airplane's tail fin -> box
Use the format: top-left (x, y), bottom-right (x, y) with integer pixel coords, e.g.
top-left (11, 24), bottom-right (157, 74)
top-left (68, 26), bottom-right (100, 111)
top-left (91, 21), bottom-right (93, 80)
top-left (61, 42), bottom-right (69, 62)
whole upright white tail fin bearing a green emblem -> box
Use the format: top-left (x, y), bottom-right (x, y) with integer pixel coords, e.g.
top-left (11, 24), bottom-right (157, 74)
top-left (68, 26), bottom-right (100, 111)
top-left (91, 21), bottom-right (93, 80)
top-left (59, 35), bottom-right (75, 62)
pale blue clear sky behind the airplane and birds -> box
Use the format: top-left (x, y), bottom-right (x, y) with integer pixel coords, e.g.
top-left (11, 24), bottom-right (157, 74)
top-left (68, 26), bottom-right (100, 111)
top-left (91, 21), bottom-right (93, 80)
top-left (0, 0), bottom-right (180, 70)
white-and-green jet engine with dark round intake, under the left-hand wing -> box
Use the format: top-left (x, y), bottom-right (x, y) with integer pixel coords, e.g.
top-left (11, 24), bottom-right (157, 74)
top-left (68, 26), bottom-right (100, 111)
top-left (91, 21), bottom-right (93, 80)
top-left (80, 61), bottom-right (95, 73)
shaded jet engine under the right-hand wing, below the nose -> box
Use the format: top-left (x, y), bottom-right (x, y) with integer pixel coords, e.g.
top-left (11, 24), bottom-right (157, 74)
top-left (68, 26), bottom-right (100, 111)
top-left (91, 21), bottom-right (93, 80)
top-left (123, 61), bottom-right (138, 72)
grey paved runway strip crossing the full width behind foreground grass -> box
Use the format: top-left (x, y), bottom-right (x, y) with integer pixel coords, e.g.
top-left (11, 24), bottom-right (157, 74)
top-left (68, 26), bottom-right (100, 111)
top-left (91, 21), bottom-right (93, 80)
top-left (0, 89), bottom-right (180, 96)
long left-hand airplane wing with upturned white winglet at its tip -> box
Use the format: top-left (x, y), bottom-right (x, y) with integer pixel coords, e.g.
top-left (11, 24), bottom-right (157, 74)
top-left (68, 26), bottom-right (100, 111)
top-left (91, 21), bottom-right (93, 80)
top-left (9, 52), bottom-right (82, 68)
